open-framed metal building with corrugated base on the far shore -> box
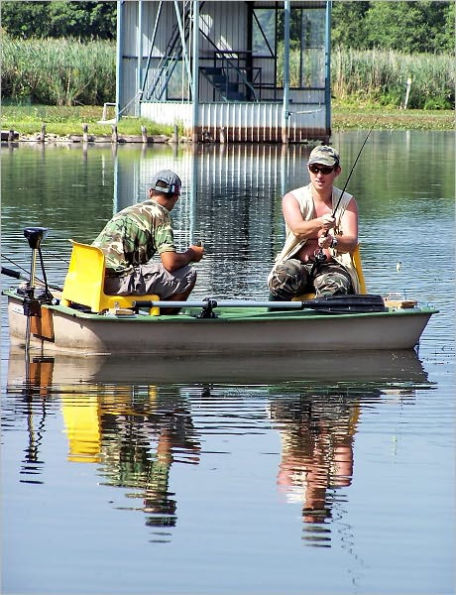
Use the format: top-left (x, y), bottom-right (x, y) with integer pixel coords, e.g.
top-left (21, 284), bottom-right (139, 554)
top-left (116, 0), bottom-right (331, 143)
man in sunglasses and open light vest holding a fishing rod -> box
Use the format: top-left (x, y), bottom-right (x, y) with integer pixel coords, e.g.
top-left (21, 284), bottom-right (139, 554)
top-left (268, 145), bottom-right (360, 301)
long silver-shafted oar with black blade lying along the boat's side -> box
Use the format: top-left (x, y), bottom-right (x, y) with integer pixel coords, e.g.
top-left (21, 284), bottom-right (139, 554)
top-left (130, 294), bottom-right (388, 318)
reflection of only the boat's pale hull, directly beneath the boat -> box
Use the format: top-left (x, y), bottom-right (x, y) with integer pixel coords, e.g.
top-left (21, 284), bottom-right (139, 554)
top-left (8, 348), bottom-right (427, 389)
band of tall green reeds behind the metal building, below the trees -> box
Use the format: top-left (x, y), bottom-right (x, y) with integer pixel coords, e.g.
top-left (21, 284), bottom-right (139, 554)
top-left (1, 35), bottom-right (456, 109)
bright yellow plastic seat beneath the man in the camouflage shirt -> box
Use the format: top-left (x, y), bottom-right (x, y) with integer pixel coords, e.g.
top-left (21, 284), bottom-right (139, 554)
top-left (61, 240), bottom-right (160, 315)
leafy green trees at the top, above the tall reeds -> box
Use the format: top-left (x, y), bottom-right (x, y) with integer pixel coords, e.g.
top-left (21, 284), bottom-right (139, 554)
top-left (0, 0), bottom-right (455, 54)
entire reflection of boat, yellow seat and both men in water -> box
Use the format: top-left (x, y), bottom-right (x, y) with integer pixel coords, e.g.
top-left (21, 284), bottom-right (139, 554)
top-left (7, 352), bottom-right (431, 547)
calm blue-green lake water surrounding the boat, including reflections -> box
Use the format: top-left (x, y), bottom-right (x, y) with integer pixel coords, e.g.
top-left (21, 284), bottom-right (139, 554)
top-left (1, 132), bottom-right (455, 594)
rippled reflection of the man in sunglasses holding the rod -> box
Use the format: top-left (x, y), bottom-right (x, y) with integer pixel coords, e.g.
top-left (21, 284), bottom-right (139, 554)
top-left (270, 394), bottom-right (359, 524)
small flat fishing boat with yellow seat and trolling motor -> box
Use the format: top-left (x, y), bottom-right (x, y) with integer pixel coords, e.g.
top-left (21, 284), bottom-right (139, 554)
top-left (2, 228), bottom-right (436, 356)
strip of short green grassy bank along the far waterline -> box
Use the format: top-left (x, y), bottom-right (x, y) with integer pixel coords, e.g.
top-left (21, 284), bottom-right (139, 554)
top-left (1, 103), bottom-right (454, 137)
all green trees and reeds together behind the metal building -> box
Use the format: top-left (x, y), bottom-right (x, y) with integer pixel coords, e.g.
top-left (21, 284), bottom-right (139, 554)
top-left (1, 0), bottom-right (456, 110)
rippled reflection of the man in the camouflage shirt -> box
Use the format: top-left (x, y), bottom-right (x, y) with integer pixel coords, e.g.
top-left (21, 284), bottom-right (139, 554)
top-left (101, 386), bottom-right (200, 527)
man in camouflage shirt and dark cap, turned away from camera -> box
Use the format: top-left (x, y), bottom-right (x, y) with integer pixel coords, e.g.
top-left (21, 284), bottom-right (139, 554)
top-left (93, 170), bottom-right (204, 313)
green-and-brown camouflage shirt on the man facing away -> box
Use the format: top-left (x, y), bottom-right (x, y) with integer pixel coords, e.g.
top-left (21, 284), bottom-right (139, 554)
top-left (92, 200), bottom-right (176, 275)
